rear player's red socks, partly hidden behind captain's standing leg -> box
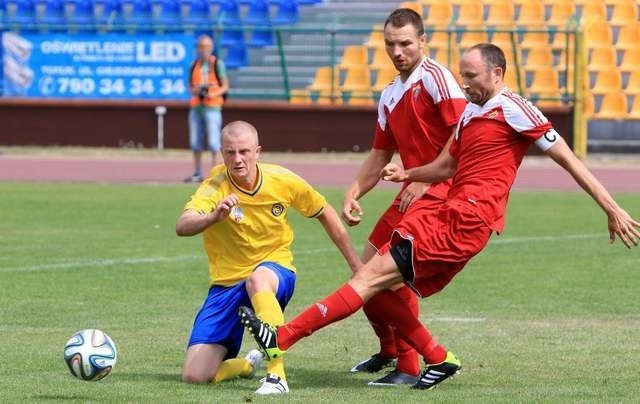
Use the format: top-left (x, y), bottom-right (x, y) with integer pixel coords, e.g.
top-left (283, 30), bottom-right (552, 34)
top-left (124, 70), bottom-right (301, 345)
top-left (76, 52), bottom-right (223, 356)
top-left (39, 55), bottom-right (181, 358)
top-left (364, 286), bottom-right (420, 376)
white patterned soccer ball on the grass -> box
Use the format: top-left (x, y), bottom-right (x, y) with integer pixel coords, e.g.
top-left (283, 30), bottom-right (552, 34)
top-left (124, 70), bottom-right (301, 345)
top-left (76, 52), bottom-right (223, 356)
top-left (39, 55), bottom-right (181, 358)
top-left (64, 329), bottom-right (118, 382)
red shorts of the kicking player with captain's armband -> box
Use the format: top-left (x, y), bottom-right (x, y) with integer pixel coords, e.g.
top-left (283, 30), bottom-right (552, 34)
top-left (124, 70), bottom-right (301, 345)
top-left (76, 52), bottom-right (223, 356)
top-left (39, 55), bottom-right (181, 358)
top-left (379, 201), bottom-right (491, 297)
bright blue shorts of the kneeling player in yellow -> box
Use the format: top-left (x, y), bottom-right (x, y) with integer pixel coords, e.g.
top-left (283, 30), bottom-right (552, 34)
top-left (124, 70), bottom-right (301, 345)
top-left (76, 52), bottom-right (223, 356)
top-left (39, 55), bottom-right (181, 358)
top-left (189, 262), bottom-right (296, 359)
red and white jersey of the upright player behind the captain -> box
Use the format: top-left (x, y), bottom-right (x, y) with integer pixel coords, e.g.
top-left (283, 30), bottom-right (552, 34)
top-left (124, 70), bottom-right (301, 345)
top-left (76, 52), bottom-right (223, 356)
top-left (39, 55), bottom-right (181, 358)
top-left (373, 58), bottom-right (467, 199)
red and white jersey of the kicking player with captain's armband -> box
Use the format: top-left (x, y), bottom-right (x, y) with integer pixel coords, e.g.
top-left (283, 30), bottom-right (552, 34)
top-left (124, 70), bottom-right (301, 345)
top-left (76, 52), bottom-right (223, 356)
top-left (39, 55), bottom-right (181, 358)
top-left (448, 88), bottom-right (558, 232)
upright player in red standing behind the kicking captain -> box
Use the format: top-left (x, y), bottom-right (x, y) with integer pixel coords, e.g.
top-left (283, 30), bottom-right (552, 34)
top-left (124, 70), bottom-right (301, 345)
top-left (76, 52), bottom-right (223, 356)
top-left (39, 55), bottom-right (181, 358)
top-left (342, 8), bottom-right (467, 386)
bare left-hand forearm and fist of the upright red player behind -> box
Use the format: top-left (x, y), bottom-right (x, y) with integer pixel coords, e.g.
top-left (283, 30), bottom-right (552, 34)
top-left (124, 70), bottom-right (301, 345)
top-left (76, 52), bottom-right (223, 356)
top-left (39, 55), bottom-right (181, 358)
top-left (342, 149), bottom-right (393, 226)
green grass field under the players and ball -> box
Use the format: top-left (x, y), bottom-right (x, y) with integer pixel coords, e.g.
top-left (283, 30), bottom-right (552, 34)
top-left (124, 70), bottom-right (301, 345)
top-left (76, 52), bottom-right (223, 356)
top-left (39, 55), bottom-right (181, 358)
top-left (0, 183), bottom-right (640, 403)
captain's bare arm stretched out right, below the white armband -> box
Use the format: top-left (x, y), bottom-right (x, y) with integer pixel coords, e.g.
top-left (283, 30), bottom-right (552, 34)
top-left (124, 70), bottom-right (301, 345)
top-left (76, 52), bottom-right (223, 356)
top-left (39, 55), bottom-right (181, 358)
top-left (546, 136), bottom-right (640, 248)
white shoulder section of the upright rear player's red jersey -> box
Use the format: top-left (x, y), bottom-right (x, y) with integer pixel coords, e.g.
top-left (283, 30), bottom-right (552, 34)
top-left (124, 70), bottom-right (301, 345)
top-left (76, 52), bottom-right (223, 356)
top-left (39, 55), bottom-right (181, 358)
top-left (378, 57), bottom-right (465, 130)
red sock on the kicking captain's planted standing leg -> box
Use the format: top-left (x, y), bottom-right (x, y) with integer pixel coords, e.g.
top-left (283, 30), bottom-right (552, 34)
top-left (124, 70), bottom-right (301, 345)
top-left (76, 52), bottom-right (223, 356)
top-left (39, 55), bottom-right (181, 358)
top-left (364, 290), bottom-right (447, 364)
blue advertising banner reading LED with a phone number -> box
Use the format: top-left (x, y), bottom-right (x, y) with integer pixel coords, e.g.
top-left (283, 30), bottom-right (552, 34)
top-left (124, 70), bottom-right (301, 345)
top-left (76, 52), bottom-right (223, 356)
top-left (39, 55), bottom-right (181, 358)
top-left (2, 32), bottom-right (195, 100)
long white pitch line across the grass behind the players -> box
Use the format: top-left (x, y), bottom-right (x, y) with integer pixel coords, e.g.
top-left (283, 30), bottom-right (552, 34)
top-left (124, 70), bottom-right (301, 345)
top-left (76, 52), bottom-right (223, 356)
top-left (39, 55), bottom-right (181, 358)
top-left (0, 233), bottom-right (607, 272)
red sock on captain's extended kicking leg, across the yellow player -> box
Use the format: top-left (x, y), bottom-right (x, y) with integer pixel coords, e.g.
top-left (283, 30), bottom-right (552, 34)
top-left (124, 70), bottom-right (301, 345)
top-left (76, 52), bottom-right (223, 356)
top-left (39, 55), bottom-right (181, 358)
top-left (278, 283), bottom-right (364, 350)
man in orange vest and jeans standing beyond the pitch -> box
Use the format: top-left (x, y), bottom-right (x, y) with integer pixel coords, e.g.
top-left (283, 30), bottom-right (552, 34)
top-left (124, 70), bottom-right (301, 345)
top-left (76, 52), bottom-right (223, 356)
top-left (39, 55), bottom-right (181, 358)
top-left (185, 35), bottom-right (229, 182)
